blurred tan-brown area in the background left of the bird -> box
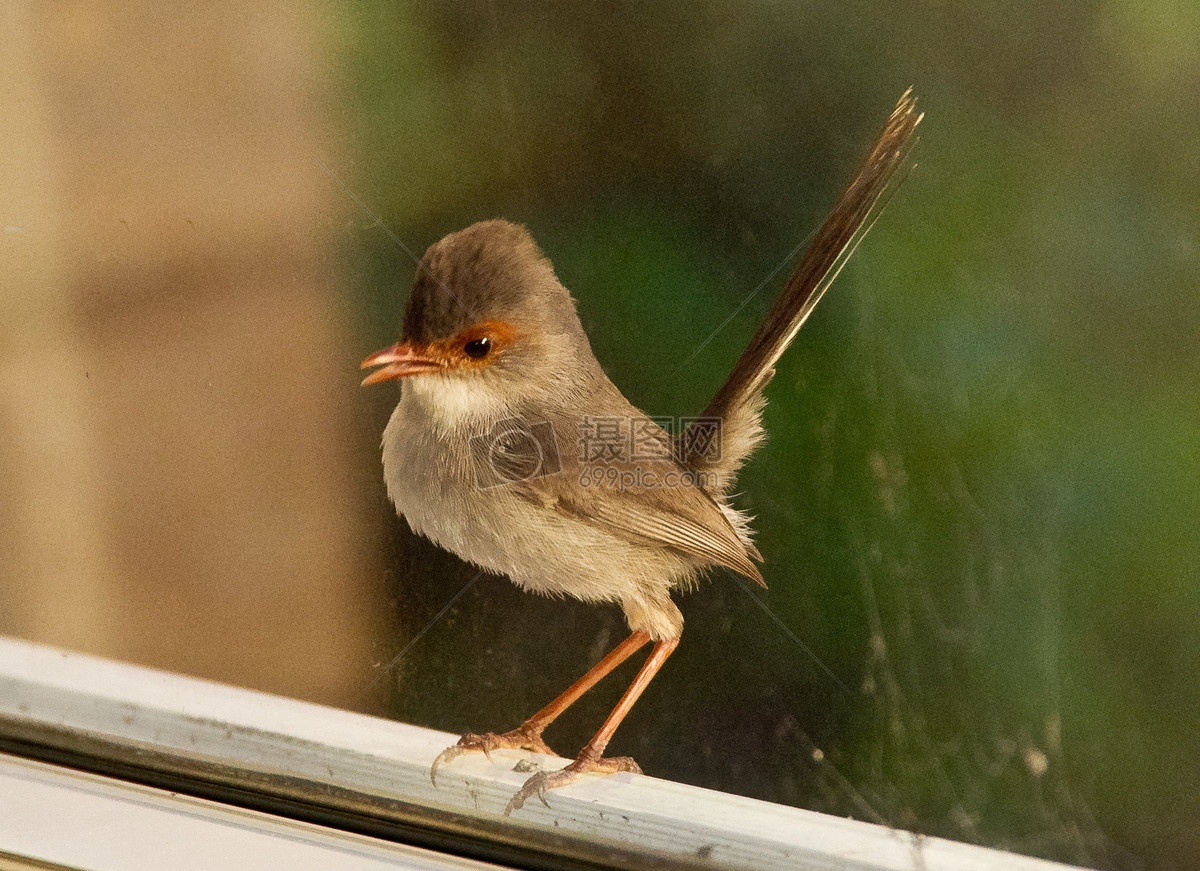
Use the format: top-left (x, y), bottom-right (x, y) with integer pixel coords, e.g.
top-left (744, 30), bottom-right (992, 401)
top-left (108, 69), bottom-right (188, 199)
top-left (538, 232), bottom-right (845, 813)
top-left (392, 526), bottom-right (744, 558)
top-left (0, 2), bottom-right (380, 703)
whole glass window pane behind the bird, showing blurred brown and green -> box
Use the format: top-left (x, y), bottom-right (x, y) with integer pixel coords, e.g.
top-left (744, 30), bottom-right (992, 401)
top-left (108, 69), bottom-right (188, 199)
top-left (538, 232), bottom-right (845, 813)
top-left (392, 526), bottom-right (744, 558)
top-left (0, 0), bottom-right (1200, 866)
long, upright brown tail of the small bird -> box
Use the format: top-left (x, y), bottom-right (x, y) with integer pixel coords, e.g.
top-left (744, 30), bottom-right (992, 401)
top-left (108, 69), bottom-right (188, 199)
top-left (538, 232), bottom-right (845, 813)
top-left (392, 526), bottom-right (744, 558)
top-left (679, 88), bottom-right (923, 494)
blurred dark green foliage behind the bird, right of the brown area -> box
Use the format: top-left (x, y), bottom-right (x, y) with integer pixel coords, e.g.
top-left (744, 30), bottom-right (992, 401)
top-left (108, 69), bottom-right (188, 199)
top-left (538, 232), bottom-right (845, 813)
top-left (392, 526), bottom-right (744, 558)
top-left (336, 0), bottom-right (1200, 867)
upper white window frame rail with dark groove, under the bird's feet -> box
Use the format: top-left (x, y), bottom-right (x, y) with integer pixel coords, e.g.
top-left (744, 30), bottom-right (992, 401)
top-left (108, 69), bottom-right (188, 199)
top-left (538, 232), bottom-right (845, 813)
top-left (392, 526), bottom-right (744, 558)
top-left (0, 637), bottom-right (1089, 871)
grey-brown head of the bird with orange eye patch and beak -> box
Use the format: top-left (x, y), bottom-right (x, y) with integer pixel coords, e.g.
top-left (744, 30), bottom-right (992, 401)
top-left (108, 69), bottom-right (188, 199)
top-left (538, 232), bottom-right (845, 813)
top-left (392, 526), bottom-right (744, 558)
top-left (362, 220), bottom-right (594, 398)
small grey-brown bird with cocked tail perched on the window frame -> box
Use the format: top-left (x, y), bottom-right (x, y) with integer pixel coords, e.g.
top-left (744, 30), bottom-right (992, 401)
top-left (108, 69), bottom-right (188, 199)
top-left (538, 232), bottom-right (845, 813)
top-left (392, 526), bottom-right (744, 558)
top-left (362, 89), bottom-right (922, 815)
